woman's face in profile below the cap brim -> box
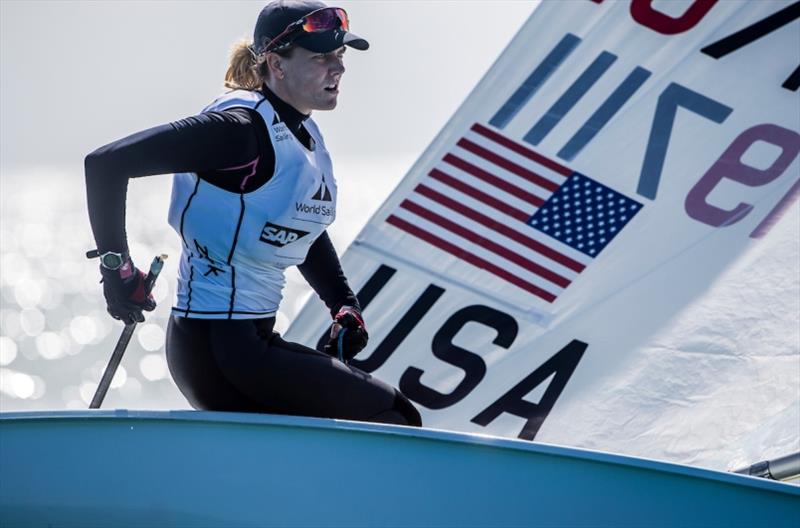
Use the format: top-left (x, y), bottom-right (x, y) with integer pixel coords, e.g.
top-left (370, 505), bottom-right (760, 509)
top-left (281, 46), bottom-right (345, 114)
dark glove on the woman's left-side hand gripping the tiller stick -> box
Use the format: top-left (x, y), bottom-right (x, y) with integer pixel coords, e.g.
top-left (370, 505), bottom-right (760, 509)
top-left (100, 257), bottom-right (156, 325)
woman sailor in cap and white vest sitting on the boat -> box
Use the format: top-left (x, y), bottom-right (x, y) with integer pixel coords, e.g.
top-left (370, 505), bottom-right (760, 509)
top-left (85, 0), bottom-right (421, 426)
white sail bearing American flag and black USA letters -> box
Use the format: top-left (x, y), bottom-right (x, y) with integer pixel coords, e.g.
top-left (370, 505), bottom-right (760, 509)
top-left (287, 0), bottom-right (800, 469)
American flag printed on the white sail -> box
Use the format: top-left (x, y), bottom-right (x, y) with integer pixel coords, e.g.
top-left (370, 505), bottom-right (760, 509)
top-left (386, 123), bottom-right (642, 303)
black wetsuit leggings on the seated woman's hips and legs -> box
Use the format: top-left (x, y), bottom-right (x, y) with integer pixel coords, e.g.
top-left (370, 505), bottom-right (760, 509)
top-left (166, 316), bottom-right (422, 426)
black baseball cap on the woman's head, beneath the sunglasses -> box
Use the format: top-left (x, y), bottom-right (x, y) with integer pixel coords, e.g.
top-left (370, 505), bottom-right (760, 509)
top-left (253, 0), bottom-right (369, 53)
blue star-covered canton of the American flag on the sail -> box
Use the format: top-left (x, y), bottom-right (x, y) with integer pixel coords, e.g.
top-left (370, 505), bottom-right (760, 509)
top-left (528, 172), bottom-right (642, 257)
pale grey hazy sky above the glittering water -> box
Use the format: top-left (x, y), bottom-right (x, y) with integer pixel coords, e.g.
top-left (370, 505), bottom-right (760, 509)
top-left (0, 0), bottom-right (537, 175)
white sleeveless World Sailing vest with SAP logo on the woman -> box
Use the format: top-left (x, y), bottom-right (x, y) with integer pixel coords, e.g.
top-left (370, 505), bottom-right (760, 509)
top-left (169, 90), bottom-right (336, 319)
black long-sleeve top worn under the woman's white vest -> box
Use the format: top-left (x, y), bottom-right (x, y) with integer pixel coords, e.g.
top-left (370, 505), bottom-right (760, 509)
top-left (85, 86), bottom-right (358, 313)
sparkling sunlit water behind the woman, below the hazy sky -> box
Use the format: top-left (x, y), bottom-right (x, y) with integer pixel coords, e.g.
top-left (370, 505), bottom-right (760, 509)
top-left (0, 161), bottom-right (382, 411)
